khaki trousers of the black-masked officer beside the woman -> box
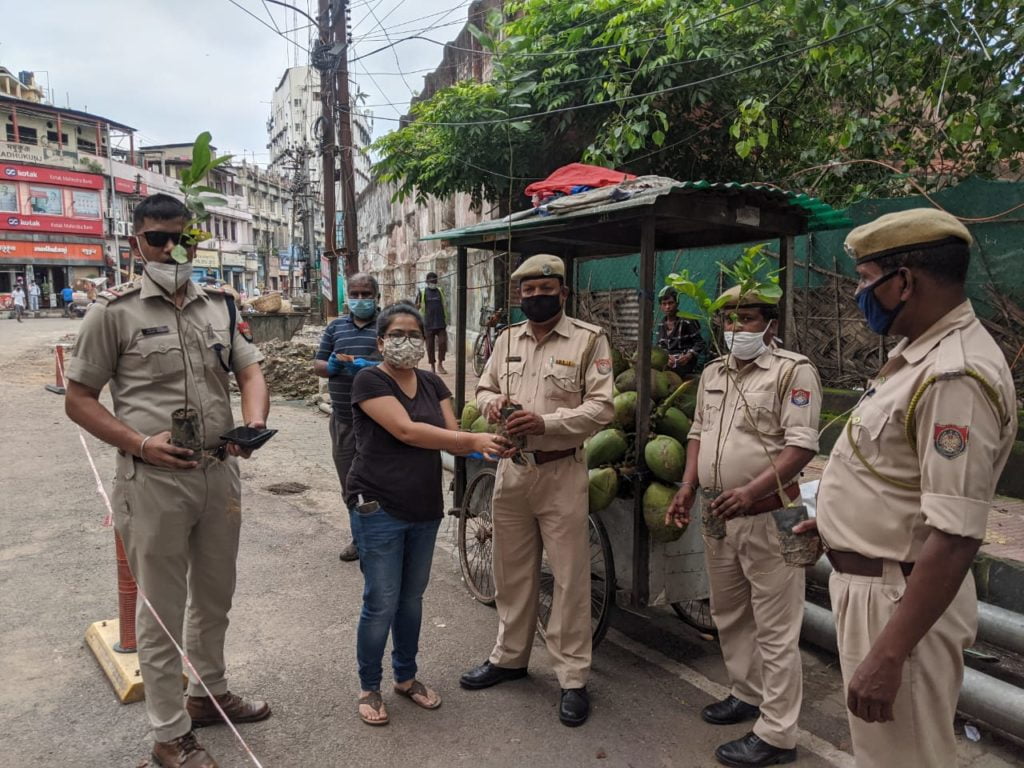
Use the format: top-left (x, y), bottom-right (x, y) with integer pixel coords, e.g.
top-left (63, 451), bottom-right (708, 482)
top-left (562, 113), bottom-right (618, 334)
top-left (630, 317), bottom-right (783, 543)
top-left (490, 451), bottom-right (591, 688)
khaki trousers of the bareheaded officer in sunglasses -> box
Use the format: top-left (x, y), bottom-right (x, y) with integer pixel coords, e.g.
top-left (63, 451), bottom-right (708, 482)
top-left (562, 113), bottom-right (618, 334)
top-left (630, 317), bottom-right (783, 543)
top-left (113, 456), bottom-right (242, 741)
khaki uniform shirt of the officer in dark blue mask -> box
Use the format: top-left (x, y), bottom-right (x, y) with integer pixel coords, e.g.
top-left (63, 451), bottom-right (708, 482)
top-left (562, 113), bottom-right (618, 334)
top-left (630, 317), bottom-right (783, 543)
top-left (817, 301), bottom-right (1017, 562)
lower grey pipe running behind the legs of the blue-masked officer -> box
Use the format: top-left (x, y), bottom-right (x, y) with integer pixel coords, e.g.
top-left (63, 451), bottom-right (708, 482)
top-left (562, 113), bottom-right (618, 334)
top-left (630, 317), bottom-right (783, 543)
top-left (802, 603), bottom-right (1024, 739)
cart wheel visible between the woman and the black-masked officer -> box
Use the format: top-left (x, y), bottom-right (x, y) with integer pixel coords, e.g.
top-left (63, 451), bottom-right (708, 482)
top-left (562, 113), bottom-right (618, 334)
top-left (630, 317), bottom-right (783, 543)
top-left (459, 467), bottom-right (496, 605)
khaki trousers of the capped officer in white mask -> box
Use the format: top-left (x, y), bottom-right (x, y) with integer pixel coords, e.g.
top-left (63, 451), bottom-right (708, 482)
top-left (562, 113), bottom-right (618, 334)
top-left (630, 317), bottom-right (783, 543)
top-left (701, 507), bottom-right (804, 750)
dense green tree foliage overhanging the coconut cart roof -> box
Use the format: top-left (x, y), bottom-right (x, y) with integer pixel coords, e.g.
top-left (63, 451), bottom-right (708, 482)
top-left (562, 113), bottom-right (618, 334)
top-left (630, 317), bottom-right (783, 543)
top-left (375, 0), bottom-right (1024, 208)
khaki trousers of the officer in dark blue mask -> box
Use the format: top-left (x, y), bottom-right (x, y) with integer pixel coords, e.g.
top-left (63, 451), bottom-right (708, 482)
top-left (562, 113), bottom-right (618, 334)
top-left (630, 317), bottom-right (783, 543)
top-left (828, 560), bottom-right (978, 768)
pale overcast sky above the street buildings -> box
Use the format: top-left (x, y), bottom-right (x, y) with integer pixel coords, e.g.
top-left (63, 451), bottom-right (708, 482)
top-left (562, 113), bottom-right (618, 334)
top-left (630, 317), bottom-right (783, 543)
top-left (0, 0), bottom-right (469, 164)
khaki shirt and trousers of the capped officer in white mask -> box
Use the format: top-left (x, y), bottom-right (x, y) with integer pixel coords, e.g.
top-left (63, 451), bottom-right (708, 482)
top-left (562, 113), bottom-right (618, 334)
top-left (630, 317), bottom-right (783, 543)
top-left (689, 348), bottom-right (821, 750)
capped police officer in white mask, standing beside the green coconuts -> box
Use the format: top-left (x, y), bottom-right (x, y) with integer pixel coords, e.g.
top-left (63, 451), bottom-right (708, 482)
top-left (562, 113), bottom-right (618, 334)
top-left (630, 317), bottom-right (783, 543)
top-left (666, 286), bottom-right (821, 766)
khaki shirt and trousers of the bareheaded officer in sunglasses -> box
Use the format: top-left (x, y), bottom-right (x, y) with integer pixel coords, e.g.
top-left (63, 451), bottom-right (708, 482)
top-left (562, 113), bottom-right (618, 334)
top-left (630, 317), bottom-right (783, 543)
top-left (68, 276), bottom-right (262, 741)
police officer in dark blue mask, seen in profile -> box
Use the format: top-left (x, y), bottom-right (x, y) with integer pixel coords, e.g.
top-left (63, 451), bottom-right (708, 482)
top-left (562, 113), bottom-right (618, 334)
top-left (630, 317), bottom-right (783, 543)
top-left (807, 209), bottom-right (1017, 768)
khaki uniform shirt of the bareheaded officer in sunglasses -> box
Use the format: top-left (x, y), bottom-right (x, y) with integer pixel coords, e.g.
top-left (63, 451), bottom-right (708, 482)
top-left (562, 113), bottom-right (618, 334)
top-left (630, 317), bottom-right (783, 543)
top-left (67, 275), bottom-right (263, 450)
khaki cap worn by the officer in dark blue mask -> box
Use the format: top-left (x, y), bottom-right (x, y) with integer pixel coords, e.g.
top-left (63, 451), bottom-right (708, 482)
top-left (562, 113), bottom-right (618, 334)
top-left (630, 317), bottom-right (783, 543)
top-left (843, 208), bottom-right (972, 264)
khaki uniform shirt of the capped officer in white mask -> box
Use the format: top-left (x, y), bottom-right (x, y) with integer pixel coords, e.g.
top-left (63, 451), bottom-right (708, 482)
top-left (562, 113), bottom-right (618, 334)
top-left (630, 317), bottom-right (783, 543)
top-left (689, 347), bottom-right (821, 490)
